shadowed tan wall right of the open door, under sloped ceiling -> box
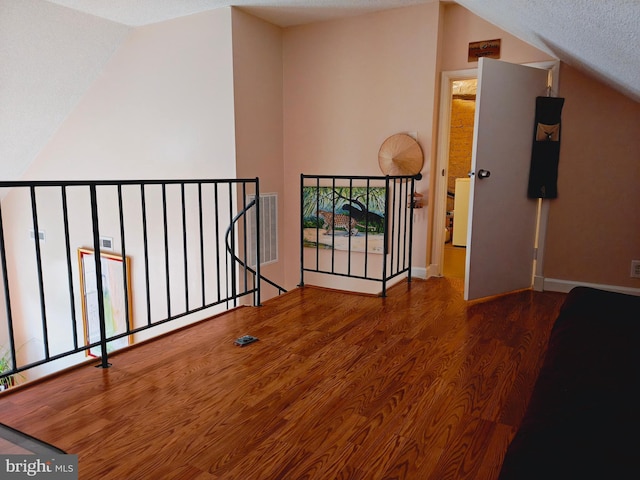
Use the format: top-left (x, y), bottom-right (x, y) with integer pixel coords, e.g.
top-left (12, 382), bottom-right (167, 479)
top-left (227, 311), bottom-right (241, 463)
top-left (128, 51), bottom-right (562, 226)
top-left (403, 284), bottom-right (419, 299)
top-left (544, 65), bottom-right (640, 289)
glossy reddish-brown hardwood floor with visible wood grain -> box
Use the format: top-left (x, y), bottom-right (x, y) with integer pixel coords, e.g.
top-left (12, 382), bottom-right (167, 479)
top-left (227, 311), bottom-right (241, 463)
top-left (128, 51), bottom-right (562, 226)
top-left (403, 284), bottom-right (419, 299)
top-left (0, 278), bottom-right (564, 480)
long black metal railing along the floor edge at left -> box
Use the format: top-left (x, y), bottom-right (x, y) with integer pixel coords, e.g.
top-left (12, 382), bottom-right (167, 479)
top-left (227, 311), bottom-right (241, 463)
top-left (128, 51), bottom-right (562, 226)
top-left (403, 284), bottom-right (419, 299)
top-left (0, 178), bottom-right (271, 389)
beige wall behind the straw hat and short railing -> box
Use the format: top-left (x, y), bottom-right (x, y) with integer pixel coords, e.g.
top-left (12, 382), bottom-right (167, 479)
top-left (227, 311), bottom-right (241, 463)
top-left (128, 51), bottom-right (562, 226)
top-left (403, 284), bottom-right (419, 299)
top-left (284, 2), bottom-right (439, 291)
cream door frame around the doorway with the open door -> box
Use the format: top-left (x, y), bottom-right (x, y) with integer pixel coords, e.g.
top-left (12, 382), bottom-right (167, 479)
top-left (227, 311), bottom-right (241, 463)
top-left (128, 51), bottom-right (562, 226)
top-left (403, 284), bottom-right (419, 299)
top-left (428, 60), bottom-right (560, 291)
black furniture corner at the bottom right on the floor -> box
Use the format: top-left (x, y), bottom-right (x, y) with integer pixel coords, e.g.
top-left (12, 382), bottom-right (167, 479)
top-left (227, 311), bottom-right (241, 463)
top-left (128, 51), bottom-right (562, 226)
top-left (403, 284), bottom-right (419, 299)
top-left (499, 287), bottom-right (640, 480)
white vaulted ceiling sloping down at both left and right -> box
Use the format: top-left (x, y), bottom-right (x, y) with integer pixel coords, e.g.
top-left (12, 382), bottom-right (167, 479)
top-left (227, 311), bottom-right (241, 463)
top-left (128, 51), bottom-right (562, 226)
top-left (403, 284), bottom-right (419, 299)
top-left (0, 0), bottom-right (640, 179)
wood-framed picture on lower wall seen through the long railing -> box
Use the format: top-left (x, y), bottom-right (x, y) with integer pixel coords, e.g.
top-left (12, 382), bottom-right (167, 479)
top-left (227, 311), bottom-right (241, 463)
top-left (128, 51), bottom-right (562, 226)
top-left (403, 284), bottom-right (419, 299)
top-left (78, 248), bottom-right (133, 357)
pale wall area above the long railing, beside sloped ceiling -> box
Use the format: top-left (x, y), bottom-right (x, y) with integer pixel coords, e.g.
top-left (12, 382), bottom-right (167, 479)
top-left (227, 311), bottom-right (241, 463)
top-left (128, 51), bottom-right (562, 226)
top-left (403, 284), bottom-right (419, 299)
top-left (24, 9), bottom-right (235, 180)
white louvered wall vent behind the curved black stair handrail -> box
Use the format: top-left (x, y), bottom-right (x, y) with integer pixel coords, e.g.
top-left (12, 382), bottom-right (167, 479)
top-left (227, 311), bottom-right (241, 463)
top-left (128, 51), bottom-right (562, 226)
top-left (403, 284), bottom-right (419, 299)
top-left (247, 193), bottom-right (278, 267)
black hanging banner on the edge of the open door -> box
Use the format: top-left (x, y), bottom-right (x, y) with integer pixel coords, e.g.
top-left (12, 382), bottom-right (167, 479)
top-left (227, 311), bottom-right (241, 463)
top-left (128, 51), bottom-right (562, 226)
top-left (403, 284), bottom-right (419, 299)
top-left (527, 97), bottom-right (564, 198)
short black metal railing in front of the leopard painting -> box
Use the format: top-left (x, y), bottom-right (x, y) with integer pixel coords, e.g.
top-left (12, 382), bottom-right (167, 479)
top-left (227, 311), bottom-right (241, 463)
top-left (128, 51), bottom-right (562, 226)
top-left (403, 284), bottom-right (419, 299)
top-left (300, 174), bottom-right (417, 296)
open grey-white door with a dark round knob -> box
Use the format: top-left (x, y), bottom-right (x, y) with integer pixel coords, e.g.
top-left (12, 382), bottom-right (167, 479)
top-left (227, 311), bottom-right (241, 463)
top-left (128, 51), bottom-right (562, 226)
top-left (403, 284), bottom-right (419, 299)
top-left (464, 58), bottom-right (548, 300)
